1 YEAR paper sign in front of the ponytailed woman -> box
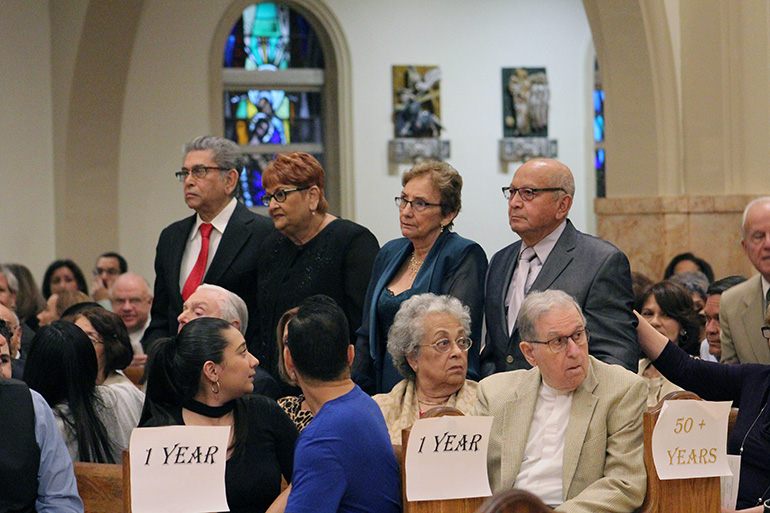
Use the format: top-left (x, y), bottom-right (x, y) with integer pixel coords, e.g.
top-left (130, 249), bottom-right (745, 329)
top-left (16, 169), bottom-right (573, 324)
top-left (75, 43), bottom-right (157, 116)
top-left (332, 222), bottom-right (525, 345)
top-left (129, 426), bottom-right (230, 513)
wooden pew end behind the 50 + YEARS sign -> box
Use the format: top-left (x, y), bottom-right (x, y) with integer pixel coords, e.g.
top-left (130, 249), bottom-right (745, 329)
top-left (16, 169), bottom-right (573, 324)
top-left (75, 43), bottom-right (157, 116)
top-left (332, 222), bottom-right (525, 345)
top-left (639, 391), bottom-right (722, 513)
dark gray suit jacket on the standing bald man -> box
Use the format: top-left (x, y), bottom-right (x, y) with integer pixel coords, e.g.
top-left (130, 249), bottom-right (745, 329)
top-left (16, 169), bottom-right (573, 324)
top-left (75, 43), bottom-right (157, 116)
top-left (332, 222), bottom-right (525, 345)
top-left (481, 220), bottom-right (639, 376)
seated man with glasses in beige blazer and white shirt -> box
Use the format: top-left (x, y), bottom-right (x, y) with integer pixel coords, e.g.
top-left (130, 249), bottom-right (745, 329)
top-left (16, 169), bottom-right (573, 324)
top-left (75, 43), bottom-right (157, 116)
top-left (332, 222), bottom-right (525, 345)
top-left (473, 290), bottom-right (647, 513)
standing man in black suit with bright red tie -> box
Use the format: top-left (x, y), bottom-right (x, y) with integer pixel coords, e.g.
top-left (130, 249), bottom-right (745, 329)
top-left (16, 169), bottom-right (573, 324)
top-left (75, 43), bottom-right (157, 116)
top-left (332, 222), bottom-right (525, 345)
top-left (142, 136), bottom-right (273, 358)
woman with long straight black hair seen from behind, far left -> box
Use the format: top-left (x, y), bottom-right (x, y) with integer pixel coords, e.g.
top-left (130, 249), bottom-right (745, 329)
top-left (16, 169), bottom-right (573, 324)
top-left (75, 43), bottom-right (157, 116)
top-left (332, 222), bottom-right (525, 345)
top-left (24, 321), bottom-right (142, 463)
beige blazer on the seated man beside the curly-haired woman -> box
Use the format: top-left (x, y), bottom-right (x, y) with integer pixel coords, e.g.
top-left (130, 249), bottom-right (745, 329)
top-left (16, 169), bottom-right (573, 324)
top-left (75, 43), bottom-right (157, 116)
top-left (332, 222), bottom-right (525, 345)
top-left (472, 356), bottom-right (647, 513)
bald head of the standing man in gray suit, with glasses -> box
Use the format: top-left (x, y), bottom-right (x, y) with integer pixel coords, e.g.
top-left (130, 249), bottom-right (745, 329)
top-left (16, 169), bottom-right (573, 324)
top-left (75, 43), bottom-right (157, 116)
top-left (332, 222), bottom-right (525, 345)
top-left (508, 159), bottom-right (575, 246)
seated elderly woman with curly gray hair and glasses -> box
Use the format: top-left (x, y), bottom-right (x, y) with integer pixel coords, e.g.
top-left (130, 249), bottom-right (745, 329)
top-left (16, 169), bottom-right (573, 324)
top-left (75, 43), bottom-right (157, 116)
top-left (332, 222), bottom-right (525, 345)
top-left (374, 293), bottom-right (478, 444)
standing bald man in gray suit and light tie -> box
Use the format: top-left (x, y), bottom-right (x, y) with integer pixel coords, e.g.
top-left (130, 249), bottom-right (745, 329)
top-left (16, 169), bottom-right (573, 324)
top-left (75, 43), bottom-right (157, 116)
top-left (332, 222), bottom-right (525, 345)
top-left (481, 159), bottom-right (638, 376)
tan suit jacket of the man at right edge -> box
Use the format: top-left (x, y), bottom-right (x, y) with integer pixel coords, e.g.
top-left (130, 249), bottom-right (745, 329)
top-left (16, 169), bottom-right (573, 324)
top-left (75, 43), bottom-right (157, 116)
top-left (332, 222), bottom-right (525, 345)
top-left (719, 274), bottom-right (770, 364)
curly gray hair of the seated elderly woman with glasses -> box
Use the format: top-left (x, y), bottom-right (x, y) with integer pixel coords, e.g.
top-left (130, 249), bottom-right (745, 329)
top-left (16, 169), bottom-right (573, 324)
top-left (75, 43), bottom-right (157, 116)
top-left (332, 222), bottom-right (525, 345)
top-left (388, 293), bottom-right (471, 379)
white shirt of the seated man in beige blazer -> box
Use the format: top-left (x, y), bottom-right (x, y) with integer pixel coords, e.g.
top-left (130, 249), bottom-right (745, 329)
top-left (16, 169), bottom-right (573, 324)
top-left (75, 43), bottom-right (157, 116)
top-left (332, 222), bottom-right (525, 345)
top-left (513, 382), bottom-right (573, 507)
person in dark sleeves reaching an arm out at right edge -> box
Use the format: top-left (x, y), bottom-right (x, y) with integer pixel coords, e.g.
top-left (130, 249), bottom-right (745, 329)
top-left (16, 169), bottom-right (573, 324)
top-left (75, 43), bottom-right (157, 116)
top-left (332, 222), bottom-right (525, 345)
top-left (637, 306), bottom-right (770, 513)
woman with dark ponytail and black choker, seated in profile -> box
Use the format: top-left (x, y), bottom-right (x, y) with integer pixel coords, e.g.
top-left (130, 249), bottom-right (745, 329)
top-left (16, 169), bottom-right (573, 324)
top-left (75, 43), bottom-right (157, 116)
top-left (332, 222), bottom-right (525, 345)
top-left (140, 317), bottom-right (297, 513)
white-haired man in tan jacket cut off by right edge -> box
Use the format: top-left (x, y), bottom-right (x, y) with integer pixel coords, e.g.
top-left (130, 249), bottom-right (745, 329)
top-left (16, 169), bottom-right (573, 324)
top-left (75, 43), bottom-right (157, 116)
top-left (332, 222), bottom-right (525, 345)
top-left (719, 196), bottom-right (770, 364)
